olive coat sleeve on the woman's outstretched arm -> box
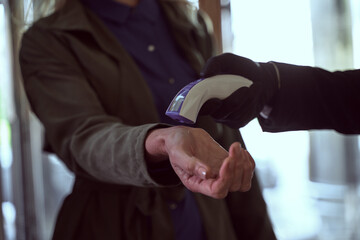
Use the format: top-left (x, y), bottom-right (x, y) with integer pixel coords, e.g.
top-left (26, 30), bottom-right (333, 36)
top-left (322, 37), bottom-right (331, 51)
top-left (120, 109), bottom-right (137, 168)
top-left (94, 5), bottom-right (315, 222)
top-left (20, 27), bottom-right (177, 186)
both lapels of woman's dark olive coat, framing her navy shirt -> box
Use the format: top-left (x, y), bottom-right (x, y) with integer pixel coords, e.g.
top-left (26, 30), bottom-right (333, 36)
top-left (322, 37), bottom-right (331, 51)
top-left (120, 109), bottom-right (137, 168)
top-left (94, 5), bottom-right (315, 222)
top-left (38, 0), bottom-right (217, 124)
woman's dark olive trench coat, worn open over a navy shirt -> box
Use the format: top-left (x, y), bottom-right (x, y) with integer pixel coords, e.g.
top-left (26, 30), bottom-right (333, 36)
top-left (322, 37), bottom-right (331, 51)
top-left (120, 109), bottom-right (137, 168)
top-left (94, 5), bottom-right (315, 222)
top-left (20, 0), bottom-right (275, 240)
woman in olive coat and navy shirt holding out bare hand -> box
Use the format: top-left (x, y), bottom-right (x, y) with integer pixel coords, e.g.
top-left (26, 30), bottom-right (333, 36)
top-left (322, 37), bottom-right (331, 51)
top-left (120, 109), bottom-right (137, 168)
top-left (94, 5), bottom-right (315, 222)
top-left (20, 0), bottom-right (275, 240)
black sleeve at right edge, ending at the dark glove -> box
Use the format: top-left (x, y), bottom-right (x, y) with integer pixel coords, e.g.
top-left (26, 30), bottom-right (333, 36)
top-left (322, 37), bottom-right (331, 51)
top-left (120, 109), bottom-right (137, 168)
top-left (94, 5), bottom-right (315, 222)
top-left (259, 63), bottom-right (360, 134)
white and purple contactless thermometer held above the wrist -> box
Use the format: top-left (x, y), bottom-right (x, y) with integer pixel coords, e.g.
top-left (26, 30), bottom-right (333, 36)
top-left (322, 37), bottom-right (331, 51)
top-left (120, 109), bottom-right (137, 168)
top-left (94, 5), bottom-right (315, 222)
top-left (165, 74), bottom-right (252, 124)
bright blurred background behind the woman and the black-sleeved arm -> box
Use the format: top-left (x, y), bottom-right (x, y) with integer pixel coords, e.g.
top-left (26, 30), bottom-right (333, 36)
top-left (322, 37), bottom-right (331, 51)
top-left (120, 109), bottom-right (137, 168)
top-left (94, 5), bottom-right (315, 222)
top-left (0, 0), bottom-right (360, 240)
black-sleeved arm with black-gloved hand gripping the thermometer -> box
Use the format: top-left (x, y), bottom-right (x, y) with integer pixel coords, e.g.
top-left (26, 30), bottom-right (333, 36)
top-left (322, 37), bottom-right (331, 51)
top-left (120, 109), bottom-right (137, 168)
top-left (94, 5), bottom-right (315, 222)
top-left (202, 53), bottom-right (360, 134)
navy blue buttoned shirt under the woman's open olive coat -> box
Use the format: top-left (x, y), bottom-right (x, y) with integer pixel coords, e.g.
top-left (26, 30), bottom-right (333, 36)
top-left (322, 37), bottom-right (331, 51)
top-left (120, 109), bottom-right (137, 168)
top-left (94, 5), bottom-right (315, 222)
top-left (82, 0), bottom-right (206, 240)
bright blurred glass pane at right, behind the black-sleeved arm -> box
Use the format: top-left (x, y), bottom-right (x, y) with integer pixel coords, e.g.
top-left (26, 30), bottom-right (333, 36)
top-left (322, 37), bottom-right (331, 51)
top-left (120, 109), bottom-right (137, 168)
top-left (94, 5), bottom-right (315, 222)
top-left (231, 0), bottom-right (360, 240)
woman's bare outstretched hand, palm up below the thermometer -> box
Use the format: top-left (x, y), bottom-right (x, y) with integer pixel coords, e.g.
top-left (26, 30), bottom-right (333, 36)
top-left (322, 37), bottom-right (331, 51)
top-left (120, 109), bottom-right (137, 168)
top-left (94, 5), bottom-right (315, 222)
top-left (145, 126), bottom-right (255, 198)
